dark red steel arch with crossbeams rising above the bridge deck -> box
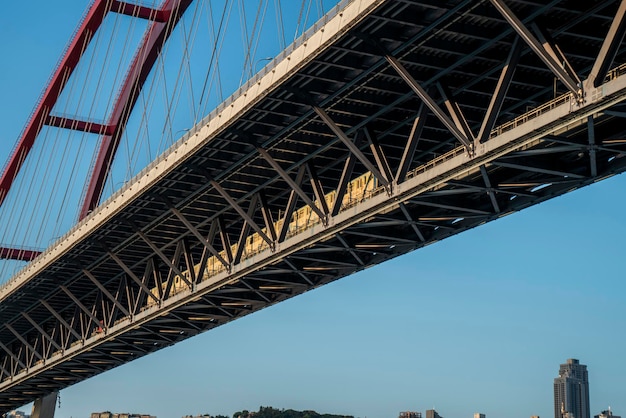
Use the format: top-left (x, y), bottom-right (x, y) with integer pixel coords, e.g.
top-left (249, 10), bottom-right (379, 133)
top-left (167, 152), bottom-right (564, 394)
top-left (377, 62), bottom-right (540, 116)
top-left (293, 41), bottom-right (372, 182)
top-left (0, 0), bottom-right (192, 261)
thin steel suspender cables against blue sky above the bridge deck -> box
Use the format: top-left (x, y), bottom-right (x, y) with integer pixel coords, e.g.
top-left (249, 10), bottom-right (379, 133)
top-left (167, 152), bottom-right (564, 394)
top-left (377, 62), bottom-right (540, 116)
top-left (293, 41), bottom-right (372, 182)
top-left (0, 0), bottom-right (336, 283)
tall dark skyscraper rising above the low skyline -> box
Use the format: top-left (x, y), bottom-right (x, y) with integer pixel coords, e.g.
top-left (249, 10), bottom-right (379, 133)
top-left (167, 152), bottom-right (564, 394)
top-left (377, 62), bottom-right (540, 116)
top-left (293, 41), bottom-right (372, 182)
top-left (554, 359), bottom-right (591, 418)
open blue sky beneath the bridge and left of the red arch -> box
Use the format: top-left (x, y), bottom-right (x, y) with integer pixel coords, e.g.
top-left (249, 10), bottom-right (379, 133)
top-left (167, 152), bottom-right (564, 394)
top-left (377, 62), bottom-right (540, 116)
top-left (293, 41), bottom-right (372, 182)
top-left (0, 0), bottom-right (626, 418)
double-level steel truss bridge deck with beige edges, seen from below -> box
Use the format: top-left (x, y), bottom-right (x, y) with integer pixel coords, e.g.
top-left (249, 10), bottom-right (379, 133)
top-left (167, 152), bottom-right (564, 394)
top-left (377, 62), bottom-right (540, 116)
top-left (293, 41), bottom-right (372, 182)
top-left (0, 0), bottom-right (626, 411)
